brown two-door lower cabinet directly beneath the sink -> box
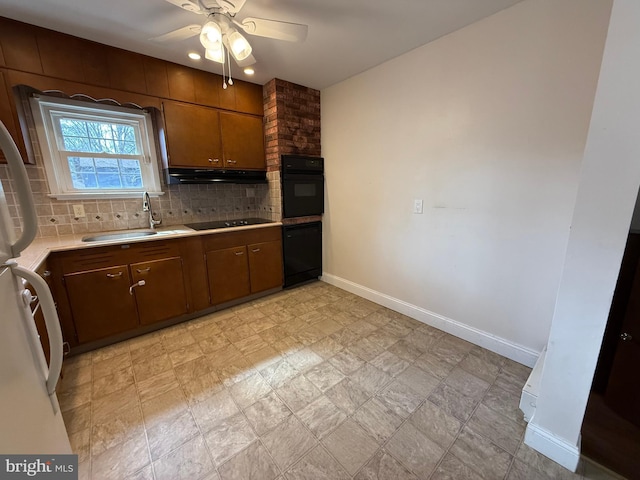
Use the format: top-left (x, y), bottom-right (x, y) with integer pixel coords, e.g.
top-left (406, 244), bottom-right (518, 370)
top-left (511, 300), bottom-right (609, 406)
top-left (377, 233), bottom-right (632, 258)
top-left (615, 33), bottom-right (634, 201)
top-left (51, 241), bottom-right (189, 346)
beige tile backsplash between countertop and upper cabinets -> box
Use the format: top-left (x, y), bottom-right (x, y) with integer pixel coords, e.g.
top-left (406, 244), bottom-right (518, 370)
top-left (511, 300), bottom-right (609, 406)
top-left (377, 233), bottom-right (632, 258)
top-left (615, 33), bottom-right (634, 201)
top-left (0, 161), bottom-right (281, 237)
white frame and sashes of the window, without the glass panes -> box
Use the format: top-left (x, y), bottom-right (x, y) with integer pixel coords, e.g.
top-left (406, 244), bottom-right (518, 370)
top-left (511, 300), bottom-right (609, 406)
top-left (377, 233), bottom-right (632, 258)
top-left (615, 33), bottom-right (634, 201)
top-left (30, 95), bottom-right (163, 200)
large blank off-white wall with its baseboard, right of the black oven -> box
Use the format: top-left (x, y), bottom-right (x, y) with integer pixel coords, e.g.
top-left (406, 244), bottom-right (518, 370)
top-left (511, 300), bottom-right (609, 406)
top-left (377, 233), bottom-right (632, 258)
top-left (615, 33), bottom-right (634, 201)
top-left (322, 0), bottom-right (611, 364)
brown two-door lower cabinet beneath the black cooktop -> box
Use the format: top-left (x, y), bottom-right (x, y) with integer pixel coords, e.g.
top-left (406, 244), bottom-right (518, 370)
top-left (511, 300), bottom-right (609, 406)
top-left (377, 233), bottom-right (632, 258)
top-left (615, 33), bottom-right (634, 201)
top-left (204, 227), bottom-right (283, 305)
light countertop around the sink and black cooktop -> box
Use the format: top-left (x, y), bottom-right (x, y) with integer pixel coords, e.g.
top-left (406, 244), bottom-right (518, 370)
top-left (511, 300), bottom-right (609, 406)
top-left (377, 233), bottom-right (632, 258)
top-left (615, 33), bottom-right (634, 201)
top-left (16, 222), bottom-right (282, 270)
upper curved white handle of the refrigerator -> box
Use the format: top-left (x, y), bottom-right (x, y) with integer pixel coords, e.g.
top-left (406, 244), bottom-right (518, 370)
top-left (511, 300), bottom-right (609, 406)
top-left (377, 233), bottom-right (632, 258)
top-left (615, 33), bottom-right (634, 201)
top-left (0, 122), bottom-right (38, 257)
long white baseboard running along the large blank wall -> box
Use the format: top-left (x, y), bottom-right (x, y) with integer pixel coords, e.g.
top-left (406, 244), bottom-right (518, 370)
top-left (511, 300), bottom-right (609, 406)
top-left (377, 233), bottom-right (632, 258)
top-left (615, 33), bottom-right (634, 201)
top-left (321, 273), bottom-right (539, 367)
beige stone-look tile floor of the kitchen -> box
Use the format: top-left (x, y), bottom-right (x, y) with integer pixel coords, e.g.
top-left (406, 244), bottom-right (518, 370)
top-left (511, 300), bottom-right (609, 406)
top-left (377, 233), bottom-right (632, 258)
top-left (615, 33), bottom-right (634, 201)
top-left (59, 282), bottom-right (613, 480)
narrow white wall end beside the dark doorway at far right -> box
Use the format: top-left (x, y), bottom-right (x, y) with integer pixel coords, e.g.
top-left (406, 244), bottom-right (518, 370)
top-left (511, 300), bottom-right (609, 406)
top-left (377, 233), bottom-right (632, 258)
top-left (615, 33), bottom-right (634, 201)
top-left (525, 0), bottom-right (640, 468)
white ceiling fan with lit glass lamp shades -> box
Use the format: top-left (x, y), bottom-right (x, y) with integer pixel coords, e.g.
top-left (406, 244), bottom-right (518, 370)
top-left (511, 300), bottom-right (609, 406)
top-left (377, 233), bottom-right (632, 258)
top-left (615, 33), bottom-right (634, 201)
top-left (152, 0), bottom-right (309, 68)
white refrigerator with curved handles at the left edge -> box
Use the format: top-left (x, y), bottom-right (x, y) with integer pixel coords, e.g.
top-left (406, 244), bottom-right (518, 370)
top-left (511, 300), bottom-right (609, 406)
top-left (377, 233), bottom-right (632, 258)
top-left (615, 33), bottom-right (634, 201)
top-left (0, 122), bottom-right (71, 454)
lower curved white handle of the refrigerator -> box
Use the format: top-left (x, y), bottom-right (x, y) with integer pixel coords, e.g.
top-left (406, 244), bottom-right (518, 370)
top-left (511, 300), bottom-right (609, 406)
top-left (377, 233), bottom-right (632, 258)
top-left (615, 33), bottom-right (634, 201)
top-left (6, 261), bottom-right (64, 411)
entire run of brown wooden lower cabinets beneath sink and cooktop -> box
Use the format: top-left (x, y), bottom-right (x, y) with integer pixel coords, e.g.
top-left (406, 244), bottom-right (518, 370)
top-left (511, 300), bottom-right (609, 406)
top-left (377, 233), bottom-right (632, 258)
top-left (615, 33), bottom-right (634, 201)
top-left (48, 226), bottom-right (283, 348)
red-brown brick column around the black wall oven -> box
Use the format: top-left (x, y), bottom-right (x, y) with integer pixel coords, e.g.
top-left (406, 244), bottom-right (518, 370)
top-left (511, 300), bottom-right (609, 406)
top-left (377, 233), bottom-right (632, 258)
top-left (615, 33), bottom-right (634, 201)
top-left (262, 78), bottom-right (321, 223)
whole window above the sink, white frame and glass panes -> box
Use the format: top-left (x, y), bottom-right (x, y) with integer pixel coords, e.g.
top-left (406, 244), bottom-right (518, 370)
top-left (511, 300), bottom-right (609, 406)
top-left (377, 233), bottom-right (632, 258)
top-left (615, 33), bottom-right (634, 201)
top-left (31, 96), bottom-right (162, 198)
